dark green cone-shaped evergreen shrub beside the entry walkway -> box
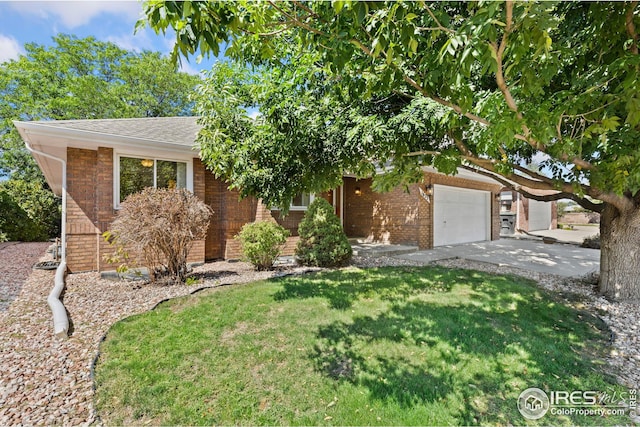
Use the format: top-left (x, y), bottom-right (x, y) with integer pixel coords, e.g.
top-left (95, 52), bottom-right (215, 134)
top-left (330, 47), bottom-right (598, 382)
top-left (296, 198), bottom-right (353, 267)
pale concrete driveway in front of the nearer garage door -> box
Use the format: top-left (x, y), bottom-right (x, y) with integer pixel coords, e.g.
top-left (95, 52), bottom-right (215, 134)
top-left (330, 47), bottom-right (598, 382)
top-left (394, 239), bottom-right (600, 277)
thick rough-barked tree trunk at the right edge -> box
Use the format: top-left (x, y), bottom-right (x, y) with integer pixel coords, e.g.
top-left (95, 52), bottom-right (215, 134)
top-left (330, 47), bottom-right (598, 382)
top-left (599, 204), bottom-right (640, 301)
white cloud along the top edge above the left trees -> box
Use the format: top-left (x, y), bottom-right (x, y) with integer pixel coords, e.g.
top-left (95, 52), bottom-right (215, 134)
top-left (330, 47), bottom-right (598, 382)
top-left (12, 0), bottom-right (142, 29)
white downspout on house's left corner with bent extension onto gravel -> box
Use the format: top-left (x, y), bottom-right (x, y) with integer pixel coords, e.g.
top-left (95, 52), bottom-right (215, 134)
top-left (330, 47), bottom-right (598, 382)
top-left (24, 139), bottom-right (69, 338)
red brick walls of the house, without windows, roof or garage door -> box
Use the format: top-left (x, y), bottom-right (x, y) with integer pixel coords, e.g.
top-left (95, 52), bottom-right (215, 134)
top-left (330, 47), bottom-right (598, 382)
top-left (67, 147), bottom-right (500, 272)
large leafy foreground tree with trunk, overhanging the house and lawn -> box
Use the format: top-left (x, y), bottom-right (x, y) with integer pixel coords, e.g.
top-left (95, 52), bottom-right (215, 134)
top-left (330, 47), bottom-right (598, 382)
top-left (145, 1), bottom-right (640, 299)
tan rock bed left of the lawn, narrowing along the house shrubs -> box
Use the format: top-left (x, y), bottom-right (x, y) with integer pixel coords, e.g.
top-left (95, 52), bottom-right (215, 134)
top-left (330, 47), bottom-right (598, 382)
top-left (0, 249), bottom-right (314, 426)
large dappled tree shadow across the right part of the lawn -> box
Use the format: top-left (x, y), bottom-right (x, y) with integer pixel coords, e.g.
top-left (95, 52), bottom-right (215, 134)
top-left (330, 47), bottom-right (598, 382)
top-left (275, 268), bottom-right (620, 425)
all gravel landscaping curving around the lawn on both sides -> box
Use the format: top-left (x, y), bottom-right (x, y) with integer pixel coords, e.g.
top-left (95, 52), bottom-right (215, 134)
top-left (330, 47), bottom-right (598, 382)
top-left (0, 243), bottom-right (640, 425)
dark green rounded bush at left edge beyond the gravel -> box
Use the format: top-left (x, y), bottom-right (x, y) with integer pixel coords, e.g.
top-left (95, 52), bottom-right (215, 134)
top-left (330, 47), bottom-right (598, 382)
top-left (0, 190), bottom-right (47, 242)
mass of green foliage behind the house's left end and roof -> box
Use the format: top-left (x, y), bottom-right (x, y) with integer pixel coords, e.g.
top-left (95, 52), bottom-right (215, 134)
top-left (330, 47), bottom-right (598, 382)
top-left (0, 35), bottom-right (200, 237)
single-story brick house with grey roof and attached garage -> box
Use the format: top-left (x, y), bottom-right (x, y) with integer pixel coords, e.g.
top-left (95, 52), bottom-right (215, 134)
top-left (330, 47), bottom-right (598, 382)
top-left (14, 117), bottom-right (502, 273)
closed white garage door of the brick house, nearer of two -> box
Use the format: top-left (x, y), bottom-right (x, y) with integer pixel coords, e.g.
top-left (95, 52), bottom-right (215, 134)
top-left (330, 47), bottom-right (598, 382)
top-left (433, 185), bottom-right (491, 246)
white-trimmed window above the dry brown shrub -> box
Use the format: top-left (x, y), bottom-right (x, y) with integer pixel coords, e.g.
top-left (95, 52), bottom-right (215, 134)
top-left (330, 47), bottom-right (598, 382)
top-left (115, 156), bottom-right (187, 206)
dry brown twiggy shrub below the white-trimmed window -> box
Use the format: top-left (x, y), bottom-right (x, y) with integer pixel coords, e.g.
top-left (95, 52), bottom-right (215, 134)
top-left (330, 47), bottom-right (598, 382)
top-left (105, 188), bottom-right (212, 283)
